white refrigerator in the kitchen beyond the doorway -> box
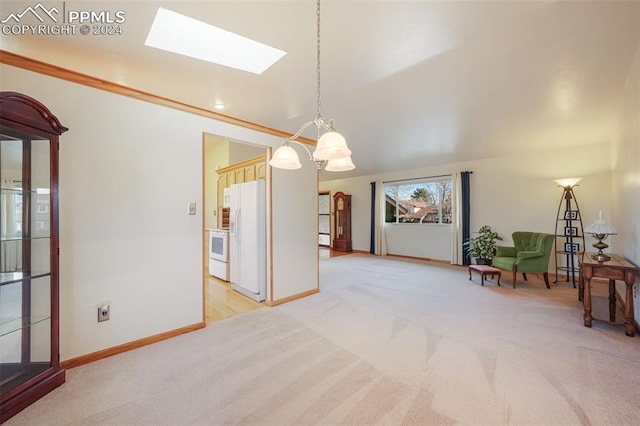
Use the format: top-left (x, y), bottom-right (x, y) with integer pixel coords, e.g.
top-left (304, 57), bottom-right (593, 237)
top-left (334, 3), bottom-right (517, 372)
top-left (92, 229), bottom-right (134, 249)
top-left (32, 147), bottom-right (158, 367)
top-left (229, 180), bottom-right (267, 302)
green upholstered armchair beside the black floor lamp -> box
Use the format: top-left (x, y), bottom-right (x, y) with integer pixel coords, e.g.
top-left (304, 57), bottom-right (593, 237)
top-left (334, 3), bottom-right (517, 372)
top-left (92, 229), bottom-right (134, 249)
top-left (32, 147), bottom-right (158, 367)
top-left (493, 231), bottom-right (555, 288)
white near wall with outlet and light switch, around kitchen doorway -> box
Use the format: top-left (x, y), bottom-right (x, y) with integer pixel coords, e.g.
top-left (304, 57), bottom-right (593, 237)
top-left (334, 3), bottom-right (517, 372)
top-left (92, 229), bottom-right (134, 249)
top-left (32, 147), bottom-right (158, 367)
top-left (0, 65), bottom-right (318, 360)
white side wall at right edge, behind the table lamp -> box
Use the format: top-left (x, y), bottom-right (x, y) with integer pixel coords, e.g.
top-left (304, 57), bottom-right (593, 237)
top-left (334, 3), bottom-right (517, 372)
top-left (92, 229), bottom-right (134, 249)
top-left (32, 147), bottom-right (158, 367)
top-left (612, 41), bottom-right (640, 322)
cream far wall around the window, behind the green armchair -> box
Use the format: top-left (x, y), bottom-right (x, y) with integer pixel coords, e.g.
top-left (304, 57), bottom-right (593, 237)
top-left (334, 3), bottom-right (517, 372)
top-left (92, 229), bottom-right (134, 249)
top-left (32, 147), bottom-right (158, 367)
top-left (320, 142), bottom-right (615, 264)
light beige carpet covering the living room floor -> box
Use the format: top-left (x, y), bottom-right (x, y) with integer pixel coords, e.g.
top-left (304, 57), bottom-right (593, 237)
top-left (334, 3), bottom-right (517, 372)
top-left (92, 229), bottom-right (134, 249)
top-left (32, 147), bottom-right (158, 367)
top-left (7, 255), bottom-right (640, 425)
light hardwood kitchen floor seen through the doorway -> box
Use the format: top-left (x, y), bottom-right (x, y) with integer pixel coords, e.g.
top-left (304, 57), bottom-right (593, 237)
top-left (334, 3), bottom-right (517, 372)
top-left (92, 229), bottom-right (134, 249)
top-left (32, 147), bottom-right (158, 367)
top-left (205, 272), bottom-right (265, 324)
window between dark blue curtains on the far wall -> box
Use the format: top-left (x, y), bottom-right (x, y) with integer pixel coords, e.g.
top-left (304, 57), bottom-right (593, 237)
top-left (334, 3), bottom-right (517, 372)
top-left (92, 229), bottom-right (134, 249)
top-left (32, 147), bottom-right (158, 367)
top-left (385, 177), bottom-right (452, 223)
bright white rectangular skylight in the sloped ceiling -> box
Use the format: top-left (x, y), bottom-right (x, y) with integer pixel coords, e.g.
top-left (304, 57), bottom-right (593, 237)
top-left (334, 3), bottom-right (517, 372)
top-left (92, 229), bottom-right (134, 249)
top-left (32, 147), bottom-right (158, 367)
top-left (144, 7), bottom-right (287, 74)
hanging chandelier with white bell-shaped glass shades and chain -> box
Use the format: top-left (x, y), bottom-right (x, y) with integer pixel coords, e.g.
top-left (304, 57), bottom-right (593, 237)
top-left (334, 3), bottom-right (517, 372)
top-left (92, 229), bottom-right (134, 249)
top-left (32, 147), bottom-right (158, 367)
top-left (269, 0), bottom-right (356, 172)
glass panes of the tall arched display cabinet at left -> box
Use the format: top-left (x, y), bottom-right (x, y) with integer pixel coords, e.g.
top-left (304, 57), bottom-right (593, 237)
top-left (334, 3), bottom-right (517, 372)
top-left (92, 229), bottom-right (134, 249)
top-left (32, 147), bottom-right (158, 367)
top-left (0, 128), bottom-right (52, 402)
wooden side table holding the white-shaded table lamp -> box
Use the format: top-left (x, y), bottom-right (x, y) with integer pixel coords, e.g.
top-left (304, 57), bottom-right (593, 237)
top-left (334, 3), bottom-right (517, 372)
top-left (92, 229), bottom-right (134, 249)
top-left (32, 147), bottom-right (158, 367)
top-left (578, 253), bottom-right (638, 337)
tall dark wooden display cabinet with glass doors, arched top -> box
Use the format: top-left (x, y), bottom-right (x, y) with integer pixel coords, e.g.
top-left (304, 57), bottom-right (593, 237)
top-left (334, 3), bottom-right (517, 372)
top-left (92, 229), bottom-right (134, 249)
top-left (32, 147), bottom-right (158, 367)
top-left (0, 92), bottom-right (67, 422)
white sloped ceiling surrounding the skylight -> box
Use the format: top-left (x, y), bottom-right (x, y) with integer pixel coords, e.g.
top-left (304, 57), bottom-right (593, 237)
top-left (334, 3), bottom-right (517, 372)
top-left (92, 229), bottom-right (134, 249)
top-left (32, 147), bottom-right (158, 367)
top-left (0, 0), bottom-right (640, 178)
